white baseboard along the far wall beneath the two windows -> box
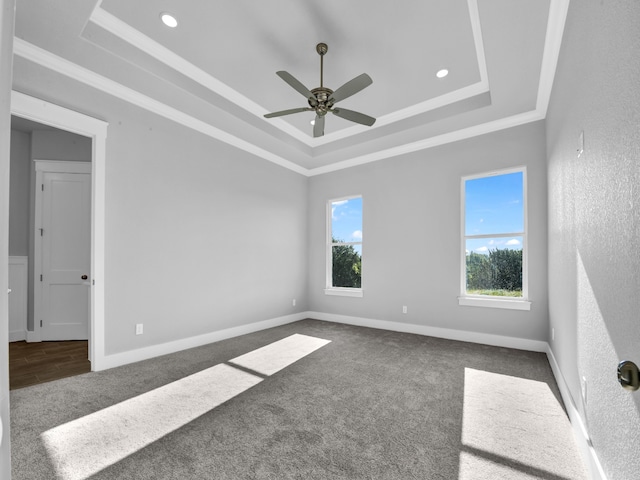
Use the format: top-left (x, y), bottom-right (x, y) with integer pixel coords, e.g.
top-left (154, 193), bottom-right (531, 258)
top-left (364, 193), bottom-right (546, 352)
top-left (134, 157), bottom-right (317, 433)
top-left (307, 312), bottom-right (547, 352)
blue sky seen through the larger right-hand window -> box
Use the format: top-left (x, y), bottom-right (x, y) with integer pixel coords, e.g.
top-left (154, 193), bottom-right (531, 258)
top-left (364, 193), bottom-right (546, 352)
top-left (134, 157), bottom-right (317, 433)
top-left (465, 172), bottom-right (524, 254)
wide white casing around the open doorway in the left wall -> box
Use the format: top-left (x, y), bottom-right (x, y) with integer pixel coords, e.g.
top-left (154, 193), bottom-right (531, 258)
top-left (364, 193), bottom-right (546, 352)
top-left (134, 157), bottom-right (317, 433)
top-left (11, 90), bottom-right (109, 371)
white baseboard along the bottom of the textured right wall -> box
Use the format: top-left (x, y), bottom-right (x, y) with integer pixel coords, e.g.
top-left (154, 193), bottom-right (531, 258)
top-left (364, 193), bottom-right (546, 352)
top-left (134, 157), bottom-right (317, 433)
top-left (546, 344), bottom-right (607, 480)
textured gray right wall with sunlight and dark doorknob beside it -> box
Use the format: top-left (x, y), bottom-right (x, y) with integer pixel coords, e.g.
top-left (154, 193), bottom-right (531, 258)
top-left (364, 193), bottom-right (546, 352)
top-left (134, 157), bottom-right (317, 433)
top-left (547, 0), bottom-right (640, 480)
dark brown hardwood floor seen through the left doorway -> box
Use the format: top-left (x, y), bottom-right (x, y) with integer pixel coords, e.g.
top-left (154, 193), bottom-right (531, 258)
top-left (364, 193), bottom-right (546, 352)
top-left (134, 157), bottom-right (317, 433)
top-left (9, 340), bottom-right (91, 390)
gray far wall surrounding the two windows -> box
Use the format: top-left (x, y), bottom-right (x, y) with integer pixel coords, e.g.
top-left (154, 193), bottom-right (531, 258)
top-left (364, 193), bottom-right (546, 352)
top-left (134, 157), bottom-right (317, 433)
top-left (308, 122), bottom-right (548, 341)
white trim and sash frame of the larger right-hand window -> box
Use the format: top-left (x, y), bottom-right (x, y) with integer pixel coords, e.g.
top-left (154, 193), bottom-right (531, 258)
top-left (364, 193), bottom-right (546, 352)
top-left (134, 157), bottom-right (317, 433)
top-left (458, 166), bottom-right (531, 310)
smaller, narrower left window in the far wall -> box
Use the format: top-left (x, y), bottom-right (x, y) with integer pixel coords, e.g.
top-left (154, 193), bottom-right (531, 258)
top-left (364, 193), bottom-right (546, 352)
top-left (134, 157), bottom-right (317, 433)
top-left (325, 196), bottom-right (362, 297)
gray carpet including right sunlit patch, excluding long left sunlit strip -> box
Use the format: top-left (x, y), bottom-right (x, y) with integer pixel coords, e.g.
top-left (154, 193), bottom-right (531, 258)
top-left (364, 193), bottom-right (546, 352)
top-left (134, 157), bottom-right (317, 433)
top-left (11, 320), bottom-right (587, 480)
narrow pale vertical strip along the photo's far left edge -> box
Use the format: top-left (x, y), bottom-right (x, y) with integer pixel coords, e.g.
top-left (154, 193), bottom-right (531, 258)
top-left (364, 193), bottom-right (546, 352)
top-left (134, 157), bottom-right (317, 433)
top-left (0, 0), bottom-right (15, 479)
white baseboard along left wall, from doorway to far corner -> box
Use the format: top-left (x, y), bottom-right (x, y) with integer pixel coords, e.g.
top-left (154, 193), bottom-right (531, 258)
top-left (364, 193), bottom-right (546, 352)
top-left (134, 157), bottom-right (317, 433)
top-left (96, 312), bottom-right (307, 371)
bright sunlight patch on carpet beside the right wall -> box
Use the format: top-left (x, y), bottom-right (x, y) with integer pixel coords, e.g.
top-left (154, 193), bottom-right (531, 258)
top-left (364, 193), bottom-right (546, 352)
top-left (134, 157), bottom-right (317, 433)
top-left (458, 368), bottom-right (586, 480)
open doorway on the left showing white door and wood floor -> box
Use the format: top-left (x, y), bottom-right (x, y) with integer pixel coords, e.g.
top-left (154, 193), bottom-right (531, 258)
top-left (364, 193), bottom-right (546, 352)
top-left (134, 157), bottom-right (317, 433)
top-left (9, 116), bottom-right (92, 388)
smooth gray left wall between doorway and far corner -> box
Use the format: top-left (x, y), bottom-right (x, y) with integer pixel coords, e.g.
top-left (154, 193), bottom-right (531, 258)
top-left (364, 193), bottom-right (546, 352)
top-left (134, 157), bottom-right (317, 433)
top-left (14, 58), bottom-right (308, 354)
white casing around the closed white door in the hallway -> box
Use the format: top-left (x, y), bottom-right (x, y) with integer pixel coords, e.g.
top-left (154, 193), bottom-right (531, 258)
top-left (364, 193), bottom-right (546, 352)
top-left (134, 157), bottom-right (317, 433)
top-left (32, 159), bottom-right (93, 344)
